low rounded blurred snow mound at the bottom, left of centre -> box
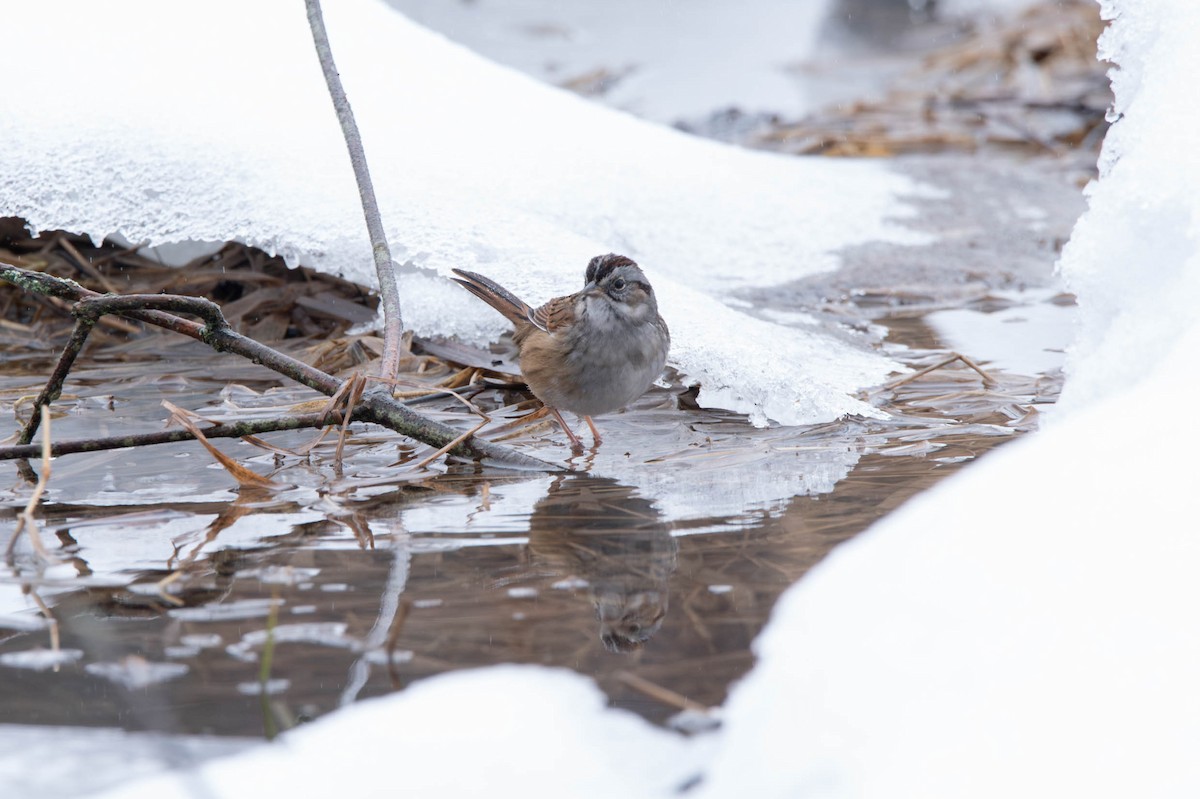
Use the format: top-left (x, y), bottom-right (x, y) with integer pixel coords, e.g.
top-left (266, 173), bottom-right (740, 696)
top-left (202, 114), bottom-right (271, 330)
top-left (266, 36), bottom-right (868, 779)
top-left (104, 666), bottom-right (707, 799)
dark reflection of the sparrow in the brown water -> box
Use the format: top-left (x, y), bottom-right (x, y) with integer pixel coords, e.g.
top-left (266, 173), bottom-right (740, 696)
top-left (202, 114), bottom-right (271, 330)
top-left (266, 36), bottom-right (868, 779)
top-left (529, 475), bottom-right (678, 653)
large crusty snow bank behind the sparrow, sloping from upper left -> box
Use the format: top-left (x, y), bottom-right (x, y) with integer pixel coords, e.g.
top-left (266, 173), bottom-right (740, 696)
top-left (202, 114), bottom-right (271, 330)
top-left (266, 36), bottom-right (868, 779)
top-left (0, 0), bottom-right (919, 423)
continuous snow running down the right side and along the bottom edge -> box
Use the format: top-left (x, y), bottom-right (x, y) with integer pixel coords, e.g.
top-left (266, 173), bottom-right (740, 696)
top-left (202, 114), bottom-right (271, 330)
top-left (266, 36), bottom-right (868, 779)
top-left (9, 0), bottom-right (1200, 799)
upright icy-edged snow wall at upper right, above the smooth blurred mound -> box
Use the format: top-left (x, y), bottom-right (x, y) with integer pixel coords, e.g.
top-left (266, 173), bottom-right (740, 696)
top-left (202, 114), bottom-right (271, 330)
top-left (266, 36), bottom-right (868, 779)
top-left (1060, 0), bottom-right (1200, 410)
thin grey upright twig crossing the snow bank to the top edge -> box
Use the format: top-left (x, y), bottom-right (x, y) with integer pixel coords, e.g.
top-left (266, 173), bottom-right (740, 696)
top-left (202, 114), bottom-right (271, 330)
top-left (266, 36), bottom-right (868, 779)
top-left (305, 0), bottom-right (404, 378)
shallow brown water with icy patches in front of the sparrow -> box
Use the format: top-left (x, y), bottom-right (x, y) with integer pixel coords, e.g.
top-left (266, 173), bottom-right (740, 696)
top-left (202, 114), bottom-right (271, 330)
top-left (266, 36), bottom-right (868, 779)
top-left (0, 286), bottom-right (1057, 758)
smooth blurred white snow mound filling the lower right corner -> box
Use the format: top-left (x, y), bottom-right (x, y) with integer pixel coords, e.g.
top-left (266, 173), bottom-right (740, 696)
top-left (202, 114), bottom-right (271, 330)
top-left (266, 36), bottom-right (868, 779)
top-left (697, 328), bottom-right (1200, 799)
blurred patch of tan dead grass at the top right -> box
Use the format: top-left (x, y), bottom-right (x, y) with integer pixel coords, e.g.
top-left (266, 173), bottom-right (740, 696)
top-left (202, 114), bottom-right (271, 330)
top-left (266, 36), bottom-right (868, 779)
top-left (756, 0), bottom-right (1111, 166)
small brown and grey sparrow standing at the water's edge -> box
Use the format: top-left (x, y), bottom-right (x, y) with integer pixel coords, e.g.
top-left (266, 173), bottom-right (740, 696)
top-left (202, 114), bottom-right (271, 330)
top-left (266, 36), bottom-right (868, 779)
top-left (452, 253), bottom-right (671, 453)
